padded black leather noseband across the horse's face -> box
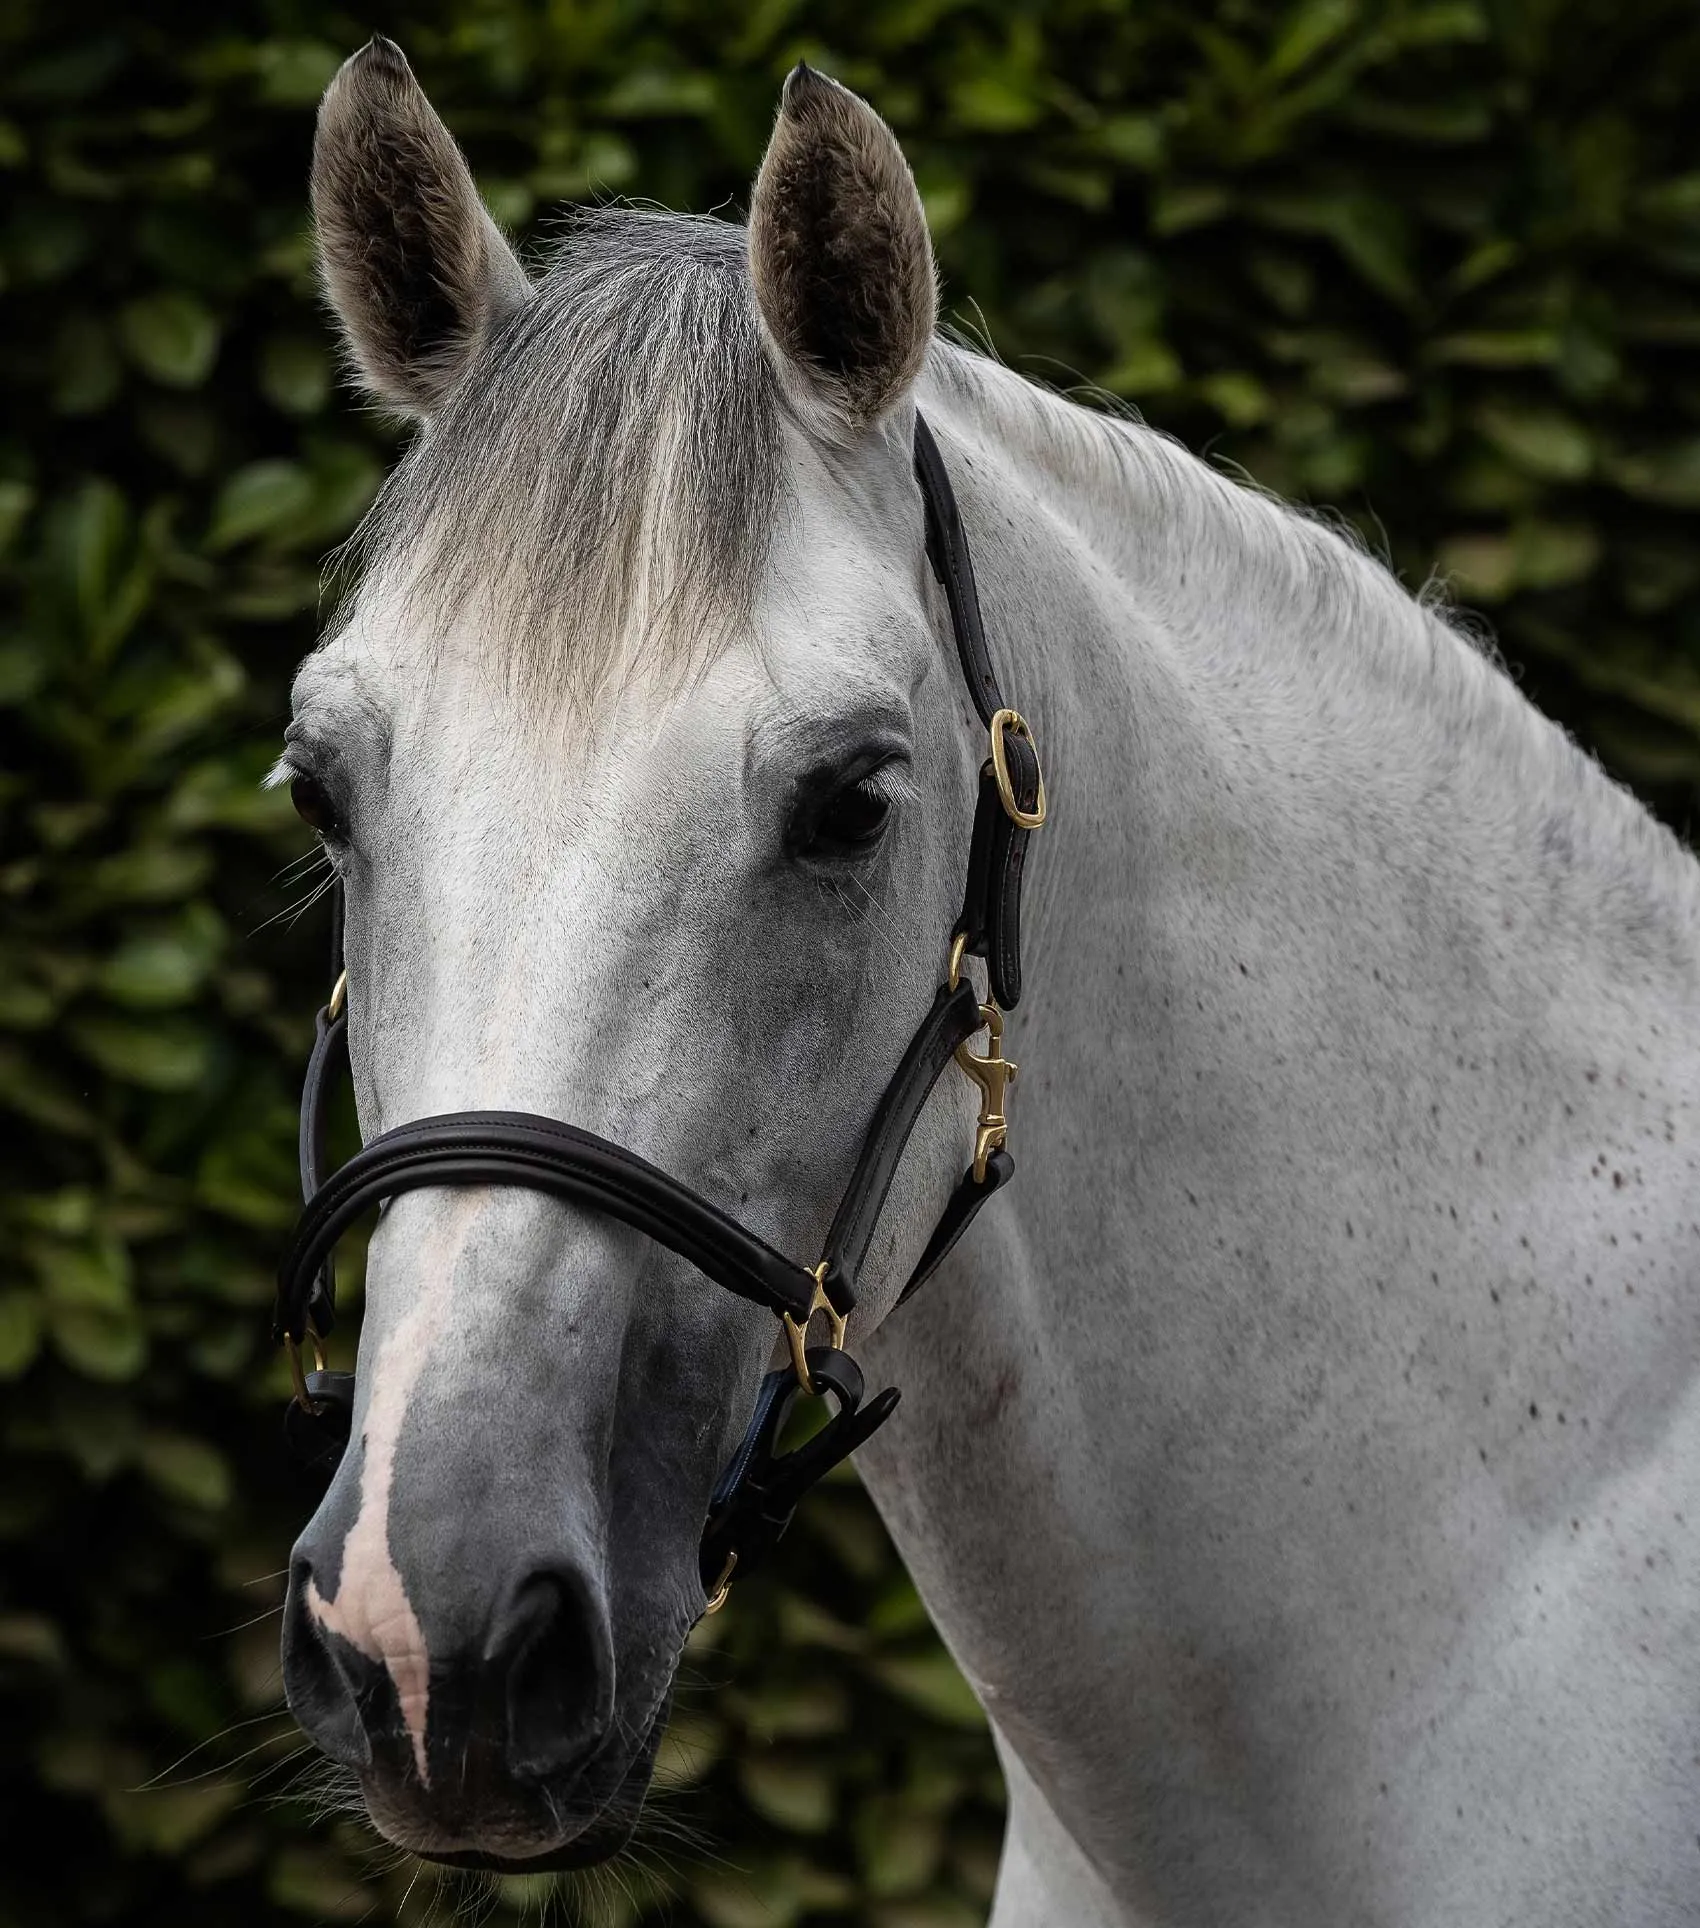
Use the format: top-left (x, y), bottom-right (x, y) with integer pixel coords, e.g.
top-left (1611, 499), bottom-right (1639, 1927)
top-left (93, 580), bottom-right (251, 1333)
top-left (276, 1111), bottom-right (815, 1344)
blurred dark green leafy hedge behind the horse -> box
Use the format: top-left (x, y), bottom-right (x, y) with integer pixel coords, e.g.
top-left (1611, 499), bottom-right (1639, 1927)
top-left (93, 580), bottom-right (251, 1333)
top-left (0, 0), bottom-right (1700, 1928)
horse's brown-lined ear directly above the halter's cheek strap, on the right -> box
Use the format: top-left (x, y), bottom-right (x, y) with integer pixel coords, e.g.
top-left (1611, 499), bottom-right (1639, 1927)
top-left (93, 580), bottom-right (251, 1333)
top-left (750, 64), bottom-right (939, 432)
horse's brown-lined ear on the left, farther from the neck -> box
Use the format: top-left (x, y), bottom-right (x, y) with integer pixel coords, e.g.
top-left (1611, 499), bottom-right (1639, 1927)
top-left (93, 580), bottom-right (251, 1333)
top-left (312, 37), bottom-right (530, 415)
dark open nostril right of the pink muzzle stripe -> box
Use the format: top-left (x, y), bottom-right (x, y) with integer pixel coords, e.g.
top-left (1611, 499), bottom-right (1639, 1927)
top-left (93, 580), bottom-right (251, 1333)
top-left (491, 1567), bottom-right (613, 1780)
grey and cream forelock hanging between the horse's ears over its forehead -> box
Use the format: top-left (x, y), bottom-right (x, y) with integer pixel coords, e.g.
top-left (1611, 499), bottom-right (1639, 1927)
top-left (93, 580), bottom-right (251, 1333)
top-left (335, 208), bottom-right (781, 711)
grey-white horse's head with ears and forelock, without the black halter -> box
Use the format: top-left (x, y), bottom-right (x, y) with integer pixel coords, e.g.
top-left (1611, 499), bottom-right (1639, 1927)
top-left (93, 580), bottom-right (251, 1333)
top-left (279, 40), bottom-right (977, 1868)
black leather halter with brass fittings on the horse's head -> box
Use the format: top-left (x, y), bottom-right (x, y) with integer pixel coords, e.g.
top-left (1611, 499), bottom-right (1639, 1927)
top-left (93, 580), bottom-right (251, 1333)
top-left (274, 415), bottom-right (1045, 1608)
